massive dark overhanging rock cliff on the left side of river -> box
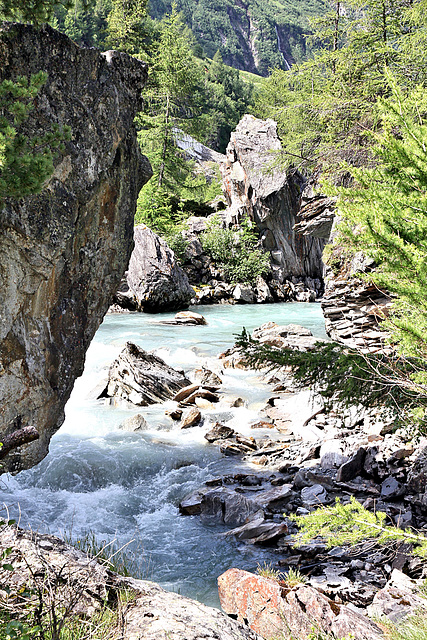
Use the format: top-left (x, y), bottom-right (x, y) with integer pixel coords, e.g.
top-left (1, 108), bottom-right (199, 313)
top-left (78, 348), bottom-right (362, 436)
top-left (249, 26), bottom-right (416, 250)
top-left (0, 23), bottom-right (151, 471)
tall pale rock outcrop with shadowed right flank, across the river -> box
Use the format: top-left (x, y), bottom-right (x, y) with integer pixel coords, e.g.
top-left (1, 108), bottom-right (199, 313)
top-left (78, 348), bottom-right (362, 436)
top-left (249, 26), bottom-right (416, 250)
top-left (221, 115), bottom-right (325, 282)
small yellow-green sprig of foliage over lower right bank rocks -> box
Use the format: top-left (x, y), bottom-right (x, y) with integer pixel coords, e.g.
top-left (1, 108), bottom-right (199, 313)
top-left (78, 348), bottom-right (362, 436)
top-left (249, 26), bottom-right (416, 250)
top-left (294, 496), bottom-right (427, 557)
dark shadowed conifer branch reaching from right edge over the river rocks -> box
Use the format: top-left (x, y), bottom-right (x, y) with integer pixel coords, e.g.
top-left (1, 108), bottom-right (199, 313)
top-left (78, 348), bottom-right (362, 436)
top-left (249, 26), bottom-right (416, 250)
top-left (236, 330), bottom-right (427, 430)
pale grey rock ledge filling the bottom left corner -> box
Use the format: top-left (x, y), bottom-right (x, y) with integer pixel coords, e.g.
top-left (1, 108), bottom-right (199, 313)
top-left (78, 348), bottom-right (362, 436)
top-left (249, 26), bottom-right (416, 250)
top-left (0, 527), bottom-right (262, 640)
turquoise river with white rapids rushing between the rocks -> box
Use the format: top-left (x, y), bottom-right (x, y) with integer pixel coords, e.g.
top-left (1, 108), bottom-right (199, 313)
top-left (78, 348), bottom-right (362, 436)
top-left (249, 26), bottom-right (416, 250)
top-left (0, 303), bottom-right (325, 606)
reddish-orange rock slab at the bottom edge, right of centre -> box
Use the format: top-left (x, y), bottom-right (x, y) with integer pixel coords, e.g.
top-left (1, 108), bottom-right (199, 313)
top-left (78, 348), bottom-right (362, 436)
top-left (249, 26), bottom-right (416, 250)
top-left (218, 569), bottom-right (383, 640)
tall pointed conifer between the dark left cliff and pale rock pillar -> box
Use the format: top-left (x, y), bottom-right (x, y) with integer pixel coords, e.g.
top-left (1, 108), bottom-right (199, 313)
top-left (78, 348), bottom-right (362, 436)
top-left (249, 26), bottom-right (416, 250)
top-left (137, 4), bottom-right (206, 228)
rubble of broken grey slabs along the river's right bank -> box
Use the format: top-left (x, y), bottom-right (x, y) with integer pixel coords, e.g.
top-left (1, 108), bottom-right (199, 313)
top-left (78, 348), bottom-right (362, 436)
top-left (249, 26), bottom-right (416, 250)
top-left (96, 322), bottom-right (427, 638)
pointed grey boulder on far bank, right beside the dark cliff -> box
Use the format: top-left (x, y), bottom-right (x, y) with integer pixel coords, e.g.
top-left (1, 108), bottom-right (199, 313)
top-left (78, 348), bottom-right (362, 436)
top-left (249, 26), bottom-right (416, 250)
top-left (114, 224), bottom-right (194, 313)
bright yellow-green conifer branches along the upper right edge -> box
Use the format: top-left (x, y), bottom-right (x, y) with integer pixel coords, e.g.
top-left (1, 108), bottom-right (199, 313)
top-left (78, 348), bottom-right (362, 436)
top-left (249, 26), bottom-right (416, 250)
top-left (332, 74), bottom-right (427, 362)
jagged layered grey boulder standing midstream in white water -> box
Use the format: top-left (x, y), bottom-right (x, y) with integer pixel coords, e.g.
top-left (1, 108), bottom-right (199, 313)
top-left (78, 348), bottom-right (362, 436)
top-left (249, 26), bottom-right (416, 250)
top-left (107, 342), bottom-right (190, 406)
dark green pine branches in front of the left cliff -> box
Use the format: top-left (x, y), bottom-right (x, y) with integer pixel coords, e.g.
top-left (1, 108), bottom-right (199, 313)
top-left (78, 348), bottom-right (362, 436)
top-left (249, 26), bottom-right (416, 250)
top-left (0, 72), bottom-right (70, 202)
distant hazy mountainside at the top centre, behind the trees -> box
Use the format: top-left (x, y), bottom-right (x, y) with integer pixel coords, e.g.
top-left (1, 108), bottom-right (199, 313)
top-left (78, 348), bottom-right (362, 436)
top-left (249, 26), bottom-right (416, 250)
top-left (150, 0), bottom-right (326, 75)
